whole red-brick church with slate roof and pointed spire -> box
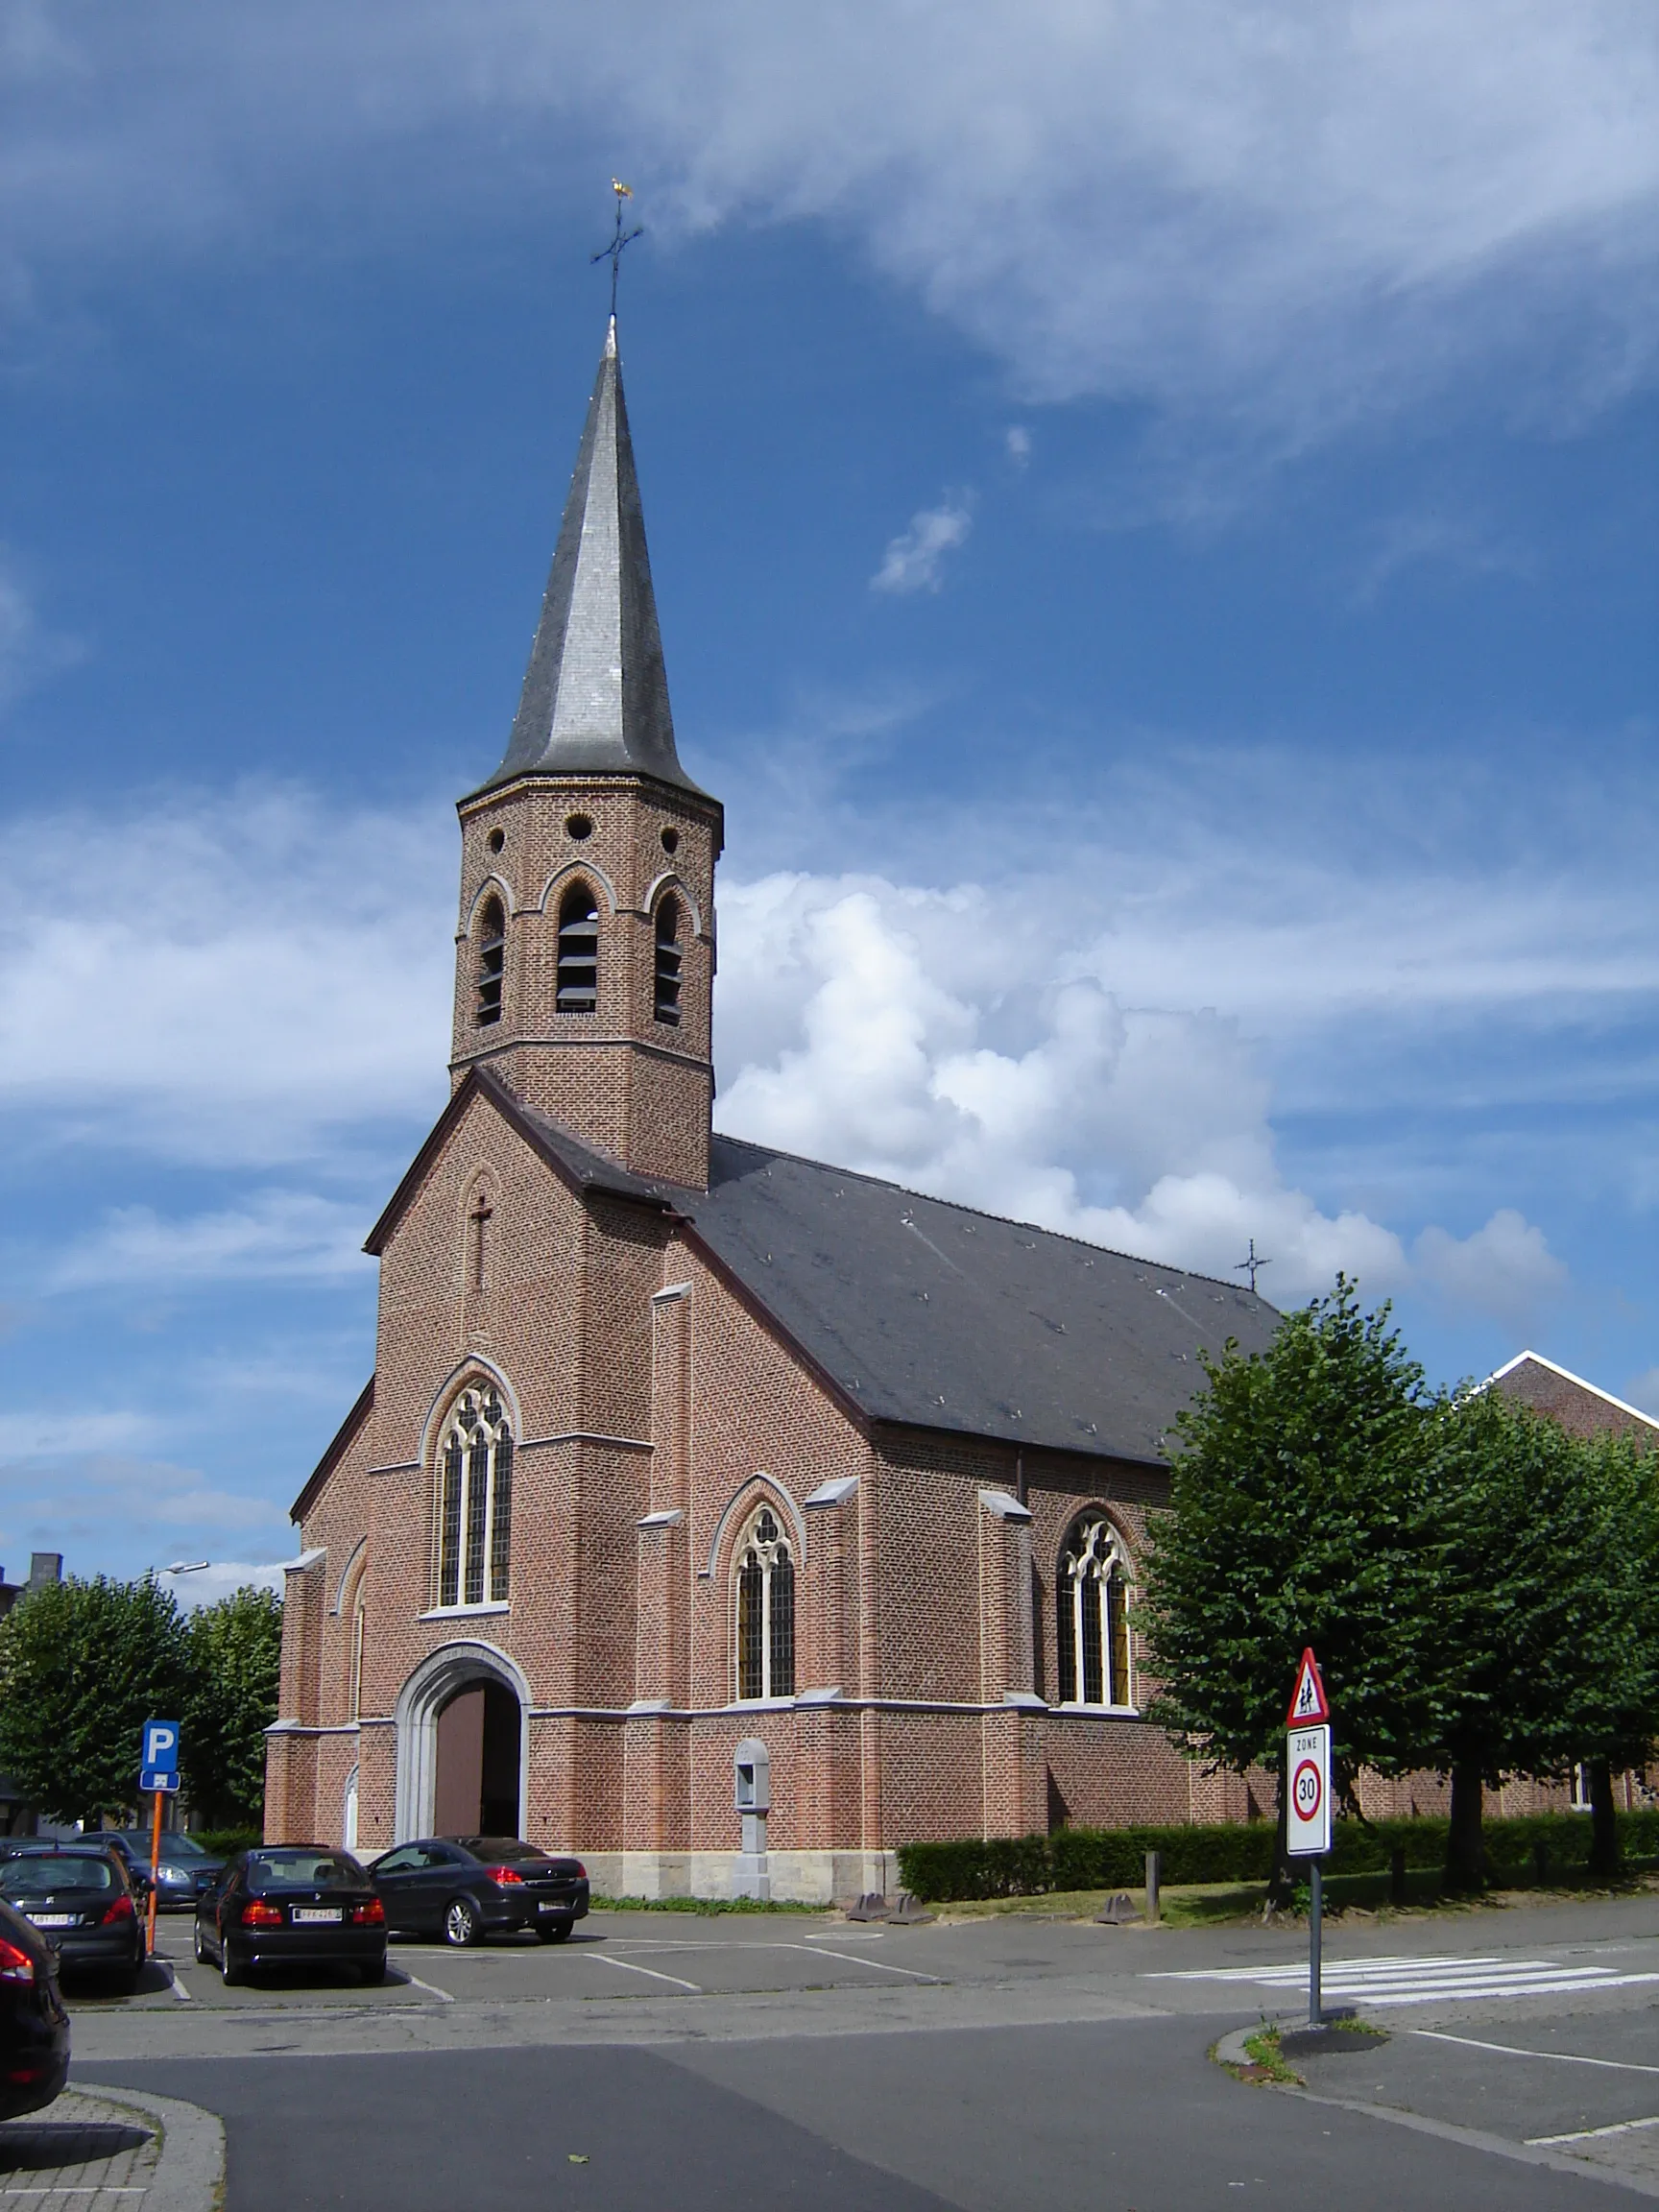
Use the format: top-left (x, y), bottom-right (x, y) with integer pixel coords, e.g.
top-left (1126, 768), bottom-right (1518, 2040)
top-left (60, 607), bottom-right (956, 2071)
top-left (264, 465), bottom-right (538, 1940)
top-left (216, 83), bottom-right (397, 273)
top-left (265, 323), bottom-right (1276, 1902)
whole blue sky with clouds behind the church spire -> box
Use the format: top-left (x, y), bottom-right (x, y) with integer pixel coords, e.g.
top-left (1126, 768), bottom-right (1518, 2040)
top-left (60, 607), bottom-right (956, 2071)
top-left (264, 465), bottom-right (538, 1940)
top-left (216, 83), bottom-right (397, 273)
top-left (0, 0), bottom-right (1659, 1591)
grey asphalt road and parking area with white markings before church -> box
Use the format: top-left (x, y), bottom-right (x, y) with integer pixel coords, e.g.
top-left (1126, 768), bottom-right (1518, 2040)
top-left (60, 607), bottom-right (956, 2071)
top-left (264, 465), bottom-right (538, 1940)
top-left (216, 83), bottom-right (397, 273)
top-left (64, 1898), bottom-right (1659, 2212)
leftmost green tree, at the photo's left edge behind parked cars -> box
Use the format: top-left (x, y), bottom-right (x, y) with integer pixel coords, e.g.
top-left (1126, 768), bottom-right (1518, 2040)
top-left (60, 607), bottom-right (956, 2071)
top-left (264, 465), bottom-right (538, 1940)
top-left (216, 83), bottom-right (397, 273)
top-left (0, 1575), bottom-right (186, 1827)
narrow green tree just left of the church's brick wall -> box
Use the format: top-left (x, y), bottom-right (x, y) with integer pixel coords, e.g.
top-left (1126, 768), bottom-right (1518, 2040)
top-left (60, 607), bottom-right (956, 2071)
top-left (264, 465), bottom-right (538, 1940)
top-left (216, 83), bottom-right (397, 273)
top-left (181, 1588), bottom-right (283, 1825)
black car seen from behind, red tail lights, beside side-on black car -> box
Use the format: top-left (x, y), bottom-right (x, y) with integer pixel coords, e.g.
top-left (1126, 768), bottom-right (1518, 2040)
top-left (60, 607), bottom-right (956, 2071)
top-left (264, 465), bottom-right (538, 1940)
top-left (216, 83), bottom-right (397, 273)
top-left (195, 1842), bottom-right (385, 1982)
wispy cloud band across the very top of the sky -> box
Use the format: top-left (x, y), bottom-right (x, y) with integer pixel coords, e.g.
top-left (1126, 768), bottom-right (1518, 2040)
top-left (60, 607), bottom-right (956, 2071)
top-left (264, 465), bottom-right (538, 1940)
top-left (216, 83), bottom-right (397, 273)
top-left (0, 0), bottom-right (1659, 434)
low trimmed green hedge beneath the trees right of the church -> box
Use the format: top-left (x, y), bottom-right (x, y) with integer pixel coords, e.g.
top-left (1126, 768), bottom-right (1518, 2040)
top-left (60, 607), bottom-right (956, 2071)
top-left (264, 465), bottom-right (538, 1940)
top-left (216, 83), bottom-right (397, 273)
top-left (898, 1810), bottom-right (1659, 1905)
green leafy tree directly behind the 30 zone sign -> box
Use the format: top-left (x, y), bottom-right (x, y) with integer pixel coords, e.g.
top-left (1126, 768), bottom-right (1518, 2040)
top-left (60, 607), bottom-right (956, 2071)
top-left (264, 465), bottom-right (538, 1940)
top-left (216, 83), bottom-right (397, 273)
top-left (1143, 1276), bottom-right (1433, 1887)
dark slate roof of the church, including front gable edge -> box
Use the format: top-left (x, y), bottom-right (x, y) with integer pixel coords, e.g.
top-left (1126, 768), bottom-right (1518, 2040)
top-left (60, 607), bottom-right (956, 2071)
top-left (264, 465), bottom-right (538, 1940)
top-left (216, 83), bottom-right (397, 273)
top-left (358, 1069), bottom-right (1279, 1462)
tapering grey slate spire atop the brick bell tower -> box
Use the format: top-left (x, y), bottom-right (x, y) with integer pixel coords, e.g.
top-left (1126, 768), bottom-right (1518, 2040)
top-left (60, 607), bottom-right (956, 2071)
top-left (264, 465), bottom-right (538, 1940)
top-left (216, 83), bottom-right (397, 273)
top-left (485, 316), bottom-right (697, 792)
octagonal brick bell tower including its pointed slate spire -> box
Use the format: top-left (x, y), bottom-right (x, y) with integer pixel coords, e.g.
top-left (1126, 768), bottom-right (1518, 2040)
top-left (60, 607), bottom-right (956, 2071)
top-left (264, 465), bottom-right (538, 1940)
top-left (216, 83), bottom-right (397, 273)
top-left (449, 316), bottom-right (723, 1190)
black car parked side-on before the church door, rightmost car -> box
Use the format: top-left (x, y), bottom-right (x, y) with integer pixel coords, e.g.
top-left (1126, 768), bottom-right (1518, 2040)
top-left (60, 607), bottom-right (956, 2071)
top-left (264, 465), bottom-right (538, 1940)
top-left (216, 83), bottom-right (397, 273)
top-left (370, 1836), bottom-right (589, 1944)
